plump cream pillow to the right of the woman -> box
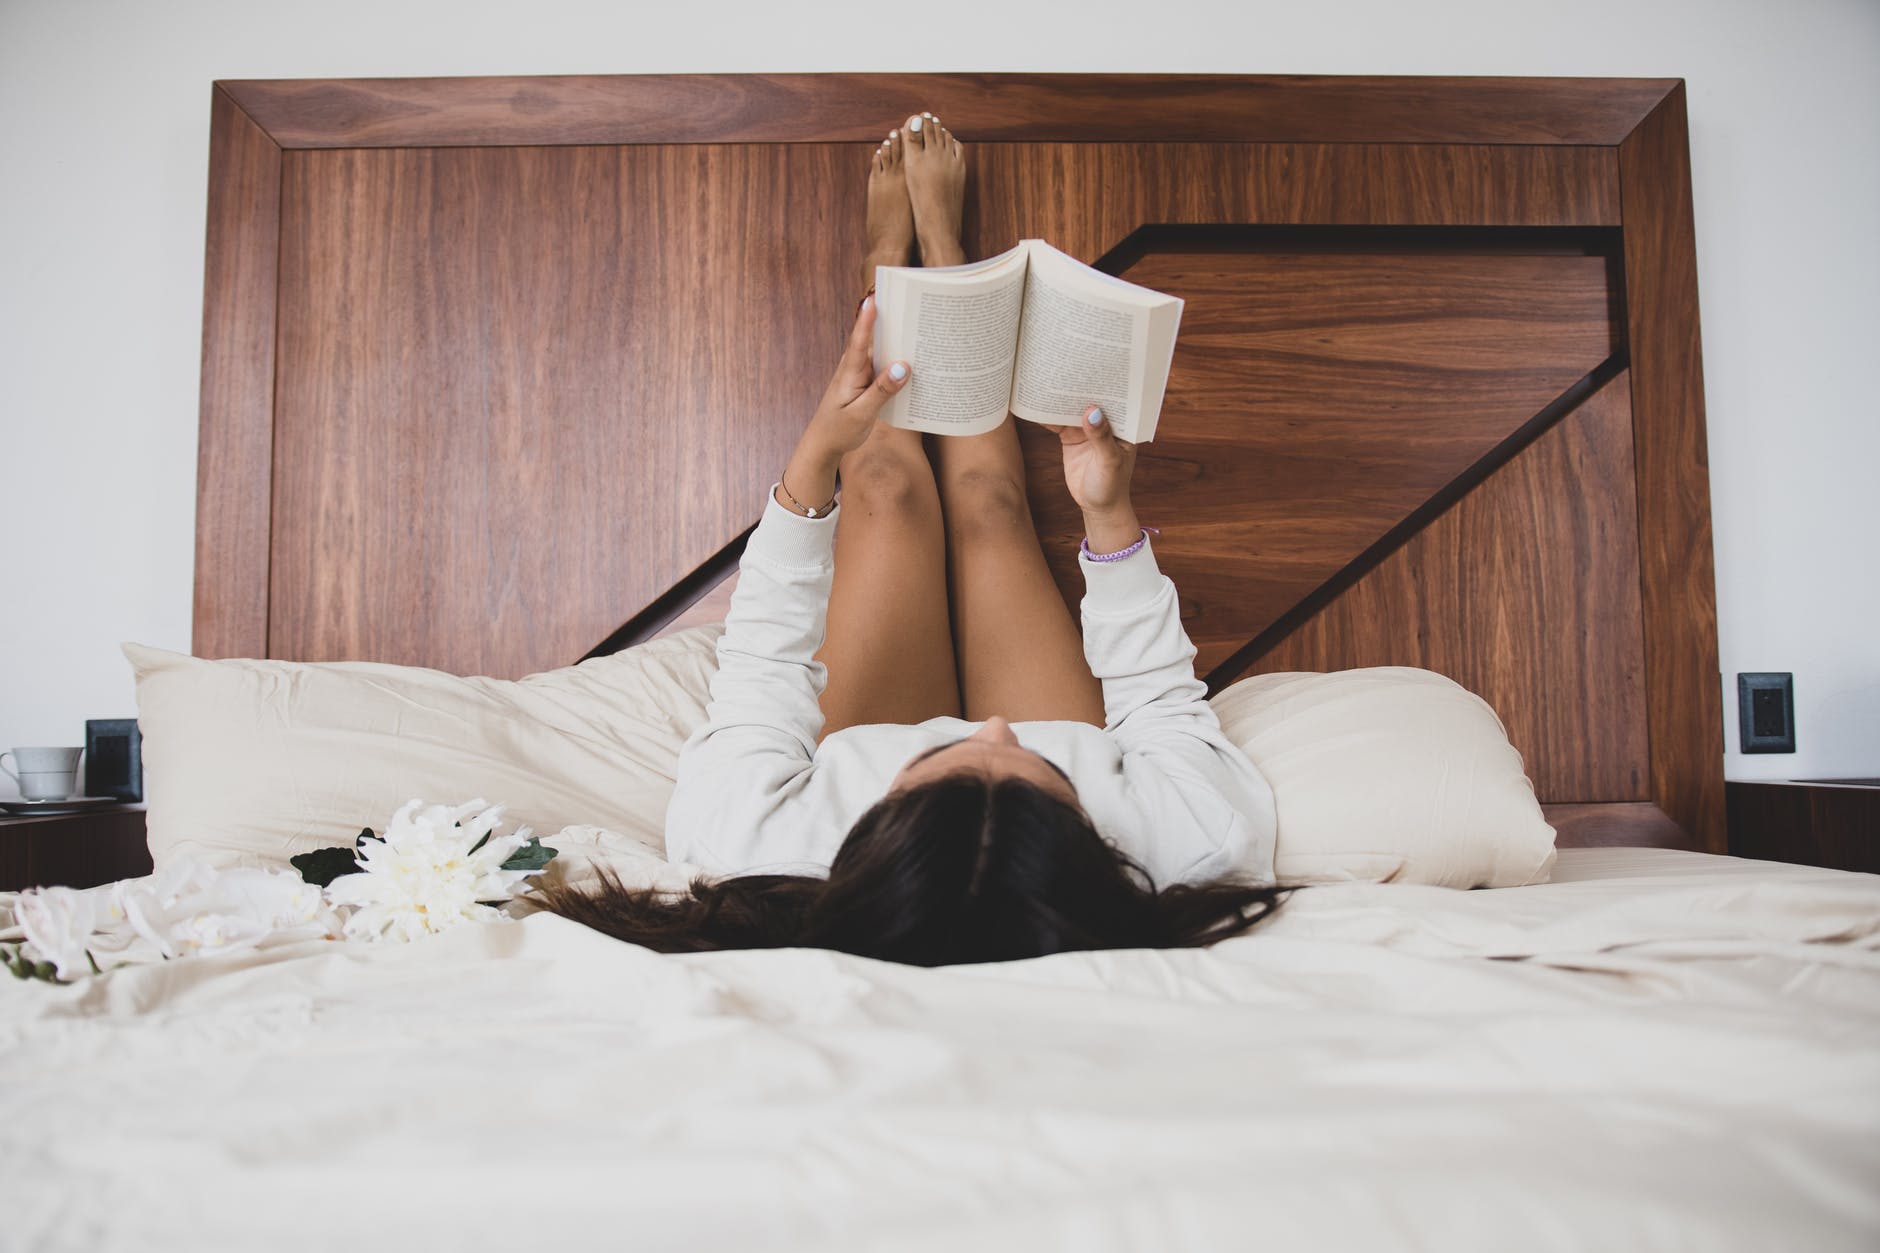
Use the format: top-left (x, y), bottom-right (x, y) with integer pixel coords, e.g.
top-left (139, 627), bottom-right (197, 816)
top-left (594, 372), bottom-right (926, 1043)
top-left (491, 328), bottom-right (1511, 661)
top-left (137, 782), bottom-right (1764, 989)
top-left (1213, 666), bottom-right (1555, 888)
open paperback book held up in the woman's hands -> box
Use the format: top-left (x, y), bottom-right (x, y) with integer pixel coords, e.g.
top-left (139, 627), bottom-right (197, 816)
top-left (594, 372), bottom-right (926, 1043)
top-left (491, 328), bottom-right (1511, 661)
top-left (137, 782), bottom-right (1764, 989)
top-left (874, 239), bottom-right (1183, 444)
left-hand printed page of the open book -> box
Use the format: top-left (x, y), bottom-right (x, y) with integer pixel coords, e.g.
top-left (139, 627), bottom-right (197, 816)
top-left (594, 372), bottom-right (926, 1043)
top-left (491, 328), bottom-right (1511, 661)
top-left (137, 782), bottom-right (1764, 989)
top-left (876, 248), bottom-right (1025, 435)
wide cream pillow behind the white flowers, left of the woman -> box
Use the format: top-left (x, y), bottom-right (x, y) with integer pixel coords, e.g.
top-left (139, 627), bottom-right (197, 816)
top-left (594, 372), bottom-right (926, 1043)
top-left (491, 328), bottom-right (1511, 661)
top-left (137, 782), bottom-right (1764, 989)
top-left (124, 623), bottom-right (724, 877)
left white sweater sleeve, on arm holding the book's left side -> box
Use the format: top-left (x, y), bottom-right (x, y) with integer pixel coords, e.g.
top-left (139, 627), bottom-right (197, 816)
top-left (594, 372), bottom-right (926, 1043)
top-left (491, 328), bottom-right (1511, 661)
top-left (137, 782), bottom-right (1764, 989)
top-left (666, 487), bottom-right (840, 873)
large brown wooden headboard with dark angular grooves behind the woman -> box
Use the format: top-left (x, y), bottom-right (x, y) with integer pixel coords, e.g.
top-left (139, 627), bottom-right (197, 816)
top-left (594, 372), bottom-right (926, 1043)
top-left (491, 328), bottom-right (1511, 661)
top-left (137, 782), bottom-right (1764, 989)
top-left (196, 75), bottom-right (1724, 852)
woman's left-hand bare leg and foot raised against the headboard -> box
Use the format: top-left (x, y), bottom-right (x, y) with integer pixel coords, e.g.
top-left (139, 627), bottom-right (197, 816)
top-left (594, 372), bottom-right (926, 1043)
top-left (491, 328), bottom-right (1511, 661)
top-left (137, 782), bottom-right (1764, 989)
top-left (816, 132), bottom-right (959, 738)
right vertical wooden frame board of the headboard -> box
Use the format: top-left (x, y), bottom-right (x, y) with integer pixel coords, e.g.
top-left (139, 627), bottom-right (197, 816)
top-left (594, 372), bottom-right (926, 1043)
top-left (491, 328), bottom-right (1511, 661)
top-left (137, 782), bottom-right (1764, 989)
top-left (1619, 85), bottom-right (1728, 852)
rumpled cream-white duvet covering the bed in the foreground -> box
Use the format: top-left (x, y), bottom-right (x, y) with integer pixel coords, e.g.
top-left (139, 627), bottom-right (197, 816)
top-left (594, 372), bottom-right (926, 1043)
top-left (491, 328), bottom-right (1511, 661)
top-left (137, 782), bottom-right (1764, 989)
top-left (0, 849), bottom-right (1880, 1253)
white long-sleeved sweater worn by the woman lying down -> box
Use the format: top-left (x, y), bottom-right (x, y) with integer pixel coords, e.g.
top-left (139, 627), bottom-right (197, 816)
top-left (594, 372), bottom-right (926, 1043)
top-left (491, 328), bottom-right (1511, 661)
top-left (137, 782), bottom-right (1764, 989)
top-left (666, 495), bottom-right (1277, 888)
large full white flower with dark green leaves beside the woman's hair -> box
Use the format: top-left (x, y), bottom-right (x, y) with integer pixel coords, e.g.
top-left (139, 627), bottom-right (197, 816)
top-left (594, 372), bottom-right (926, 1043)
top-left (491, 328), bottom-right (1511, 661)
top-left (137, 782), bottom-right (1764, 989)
top-left (327, 800), bottom-right (534, 941)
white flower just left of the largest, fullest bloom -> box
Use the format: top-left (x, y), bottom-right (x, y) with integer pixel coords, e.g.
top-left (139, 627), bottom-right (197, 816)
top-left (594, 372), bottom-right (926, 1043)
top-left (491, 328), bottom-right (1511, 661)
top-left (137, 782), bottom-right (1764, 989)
top-left (113, 858), bottom-right (340, 958)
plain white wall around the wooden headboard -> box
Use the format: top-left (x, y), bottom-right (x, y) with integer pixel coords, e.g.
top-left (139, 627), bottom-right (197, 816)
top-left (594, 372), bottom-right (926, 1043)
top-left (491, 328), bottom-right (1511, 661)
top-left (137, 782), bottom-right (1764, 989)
top-left (0, 0), bottom-right (1880, 785)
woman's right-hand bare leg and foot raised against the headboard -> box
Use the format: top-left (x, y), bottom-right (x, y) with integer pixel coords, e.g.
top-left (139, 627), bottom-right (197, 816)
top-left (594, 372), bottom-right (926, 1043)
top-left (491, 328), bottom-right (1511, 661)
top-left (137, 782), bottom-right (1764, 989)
top-left (902, 119), bottom-right (1104, 726)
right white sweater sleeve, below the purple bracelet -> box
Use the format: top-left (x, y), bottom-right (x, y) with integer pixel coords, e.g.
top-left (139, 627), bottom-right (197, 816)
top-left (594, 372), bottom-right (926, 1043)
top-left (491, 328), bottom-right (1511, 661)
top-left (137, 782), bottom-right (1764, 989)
top-left (1077, 536), bottom-right (1278, 886)
